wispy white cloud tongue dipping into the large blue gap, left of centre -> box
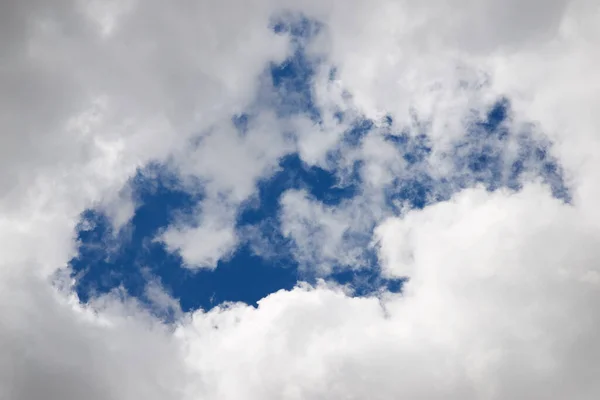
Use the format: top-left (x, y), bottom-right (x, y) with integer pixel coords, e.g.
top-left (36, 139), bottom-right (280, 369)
top-left (160, 112), bottom-right (295, 268)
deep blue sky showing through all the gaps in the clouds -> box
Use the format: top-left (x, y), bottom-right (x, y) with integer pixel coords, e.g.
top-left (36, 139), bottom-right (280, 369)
top-left (65, 19), bottom-right (569, 318)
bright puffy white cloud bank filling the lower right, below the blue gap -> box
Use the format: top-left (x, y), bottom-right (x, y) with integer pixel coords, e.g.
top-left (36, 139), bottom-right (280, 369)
top-left (182, 185), bottom-right (600, 399)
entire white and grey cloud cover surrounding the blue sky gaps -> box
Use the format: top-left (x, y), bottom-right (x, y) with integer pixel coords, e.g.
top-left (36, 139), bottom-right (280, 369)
top-left (0, 0), bottom-right (600, 400)
